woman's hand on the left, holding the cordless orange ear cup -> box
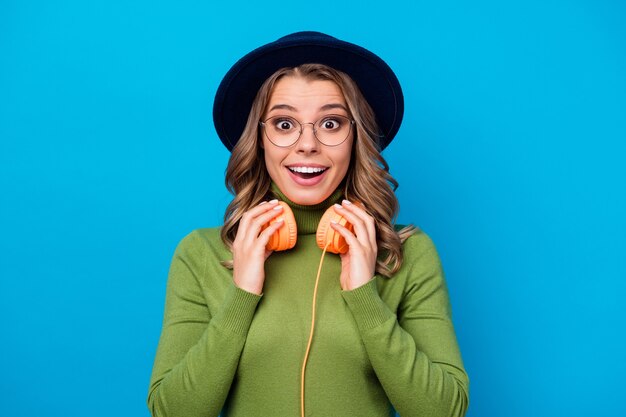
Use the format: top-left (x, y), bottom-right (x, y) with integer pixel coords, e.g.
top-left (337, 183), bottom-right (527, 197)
top-left (233, 200), bottom-right (284, 295)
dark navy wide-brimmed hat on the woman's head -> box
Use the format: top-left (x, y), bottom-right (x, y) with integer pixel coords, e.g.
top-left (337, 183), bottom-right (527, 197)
top-left (213, 32), bottom-right (404, 151)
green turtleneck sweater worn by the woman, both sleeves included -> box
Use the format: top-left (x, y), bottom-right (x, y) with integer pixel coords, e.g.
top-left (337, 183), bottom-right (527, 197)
top-left (148, 188), bottom-right (469, 417)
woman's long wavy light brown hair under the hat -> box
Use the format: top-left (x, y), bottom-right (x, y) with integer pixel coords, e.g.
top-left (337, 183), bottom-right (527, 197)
top-left (221, 64), bottom-right (416, 277)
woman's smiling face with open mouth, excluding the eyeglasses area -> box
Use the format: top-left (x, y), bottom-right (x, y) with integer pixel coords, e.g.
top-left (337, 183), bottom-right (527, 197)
top-left (262, 76), bottom-right (354, 205)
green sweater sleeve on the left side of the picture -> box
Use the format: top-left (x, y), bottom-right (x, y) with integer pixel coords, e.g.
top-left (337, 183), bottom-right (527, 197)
top-left (148, 232), bottom-right (261, 417)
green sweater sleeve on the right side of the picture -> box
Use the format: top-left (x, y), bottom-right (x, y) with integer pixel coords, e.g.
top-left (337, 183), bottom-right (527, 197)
top-left (342, 233), bottom-right (469, 417)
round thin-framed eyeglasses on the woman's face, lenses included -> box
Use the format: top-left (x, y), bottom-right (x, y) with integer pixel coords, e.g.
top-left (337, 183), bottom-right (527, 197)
top-left (259, 114), bottom-right (354, 148)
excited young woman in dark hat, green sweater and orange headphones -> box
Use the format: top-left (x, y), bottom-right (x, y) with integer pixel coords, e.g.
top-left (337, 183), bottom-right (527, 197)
top-left (148, 32), bottom-right (469, 417)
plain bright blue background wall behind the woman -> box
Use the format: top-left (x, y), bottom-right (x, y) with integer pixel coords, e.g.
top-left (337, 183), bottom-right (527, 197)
top-left (0, 0), bottom-right (626, 417)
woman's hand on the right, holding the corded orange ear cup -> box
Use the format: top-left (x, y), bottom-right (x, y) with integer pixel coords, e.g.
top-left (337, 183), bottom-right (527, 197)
top-left (330, 200), bottom-right (378, 291)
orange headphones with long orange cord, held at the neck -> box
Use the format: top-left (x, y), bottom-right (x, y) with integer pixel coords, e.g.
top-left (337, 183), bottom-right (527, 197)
top-left (263, 201), bottom-right (358, 417)
